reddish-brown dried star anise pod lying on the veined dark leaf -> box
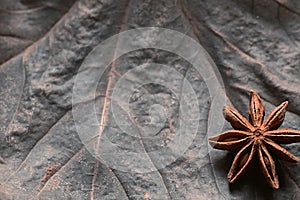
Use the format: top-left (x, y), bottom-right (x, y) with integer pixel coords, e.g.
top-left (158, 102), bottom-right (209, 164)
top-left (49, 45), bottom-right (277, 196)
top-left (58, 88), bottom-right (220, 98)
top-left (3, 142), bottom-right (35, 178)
top-left (209, 90), bottom-right (300, 189)
